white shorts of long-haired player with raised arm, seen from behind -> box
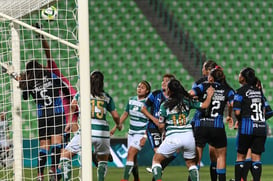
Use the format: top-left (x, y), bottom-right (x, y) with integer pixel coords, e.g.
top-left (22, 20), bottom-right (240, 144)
top-left (156, 131), bottom-right (196, 159)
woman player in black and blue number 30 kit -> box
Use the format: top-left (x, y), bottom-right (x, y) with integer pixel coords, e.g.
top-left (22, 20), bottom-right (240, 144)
top-left (233, 67), bottom-right (267, 181)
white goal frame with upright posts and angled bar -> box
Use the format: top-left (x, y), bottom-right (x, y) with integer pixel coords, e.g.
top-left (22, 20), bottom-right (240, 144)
top-left (0, 0), bottom-right (93, 181)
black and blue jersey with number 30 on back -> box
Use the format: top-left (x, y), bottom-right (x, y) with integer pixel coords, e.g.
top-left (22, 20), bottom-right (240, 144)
top-left (233, 85), bottom-right (266, 136)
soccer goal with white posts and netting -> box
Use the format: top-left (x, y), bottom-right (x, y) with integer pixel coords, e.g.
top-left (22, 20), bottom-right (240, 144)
top-left (0, 0), bottom-right (92, 181)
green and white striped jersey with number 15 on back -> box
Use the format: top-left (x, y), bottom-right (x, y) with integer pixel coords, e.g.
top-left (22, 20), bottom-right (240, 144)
top-left (74, 92), bottom-right (116, 138)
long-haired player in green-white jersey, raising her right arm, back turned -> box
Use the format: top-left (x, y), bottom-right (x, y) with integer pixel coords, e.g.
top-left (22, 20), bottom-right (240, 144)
top-left (152, 79), bottom-right (214, 181)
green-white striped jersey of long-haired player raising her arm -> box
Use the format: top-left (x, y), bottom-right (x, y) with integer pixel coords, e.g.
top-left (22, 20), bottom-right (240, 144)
top-left (159, 100), bottom-right (202, 136)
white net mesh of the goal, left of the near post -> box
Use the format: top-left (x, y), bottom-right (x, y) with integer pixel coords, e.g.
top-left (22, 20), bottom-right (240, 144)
top-left (0, 0), bottom-right (79, 180)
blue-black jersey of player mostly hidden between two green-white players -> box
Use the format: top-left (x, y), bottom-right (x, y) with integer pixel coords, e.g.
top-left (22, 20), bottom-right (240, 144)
top-left (145, 90), bottom-right (166, 128)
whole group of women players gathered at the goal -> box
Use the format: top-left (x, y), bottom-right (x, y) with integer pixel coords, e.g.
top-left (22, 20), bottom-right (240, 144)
top-left (2, 25), bottom-right (273, 181)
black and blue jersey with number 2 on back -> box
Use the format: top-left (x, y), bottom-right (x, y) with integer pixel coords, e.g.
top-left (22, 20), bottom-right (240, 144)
top-left (193, 82), bottom-right (234, 128)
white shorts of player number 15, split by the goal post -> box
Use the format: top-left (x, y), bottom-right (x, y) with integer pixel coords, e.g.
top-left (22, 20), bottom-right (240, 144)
top-left (65, 133), bottom-right (110, 155)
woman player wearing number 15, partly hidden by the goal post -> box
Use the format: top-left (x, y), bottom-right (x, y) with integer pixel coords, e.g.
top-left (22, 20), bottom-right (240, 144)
top-left (60, 71), bottom-right (121, 181)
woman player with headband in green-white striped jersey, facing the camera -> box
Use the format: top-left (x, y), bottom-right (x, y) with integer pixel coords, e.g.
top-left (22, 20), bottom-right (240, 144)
top-left (111, 81), bottom-right (151, 181)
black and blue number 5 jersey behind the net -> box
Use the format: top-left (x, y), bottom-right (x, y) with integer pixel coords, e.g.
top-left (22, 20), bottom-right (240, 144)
top-left (23, 73), bottom-right (69, 118)
